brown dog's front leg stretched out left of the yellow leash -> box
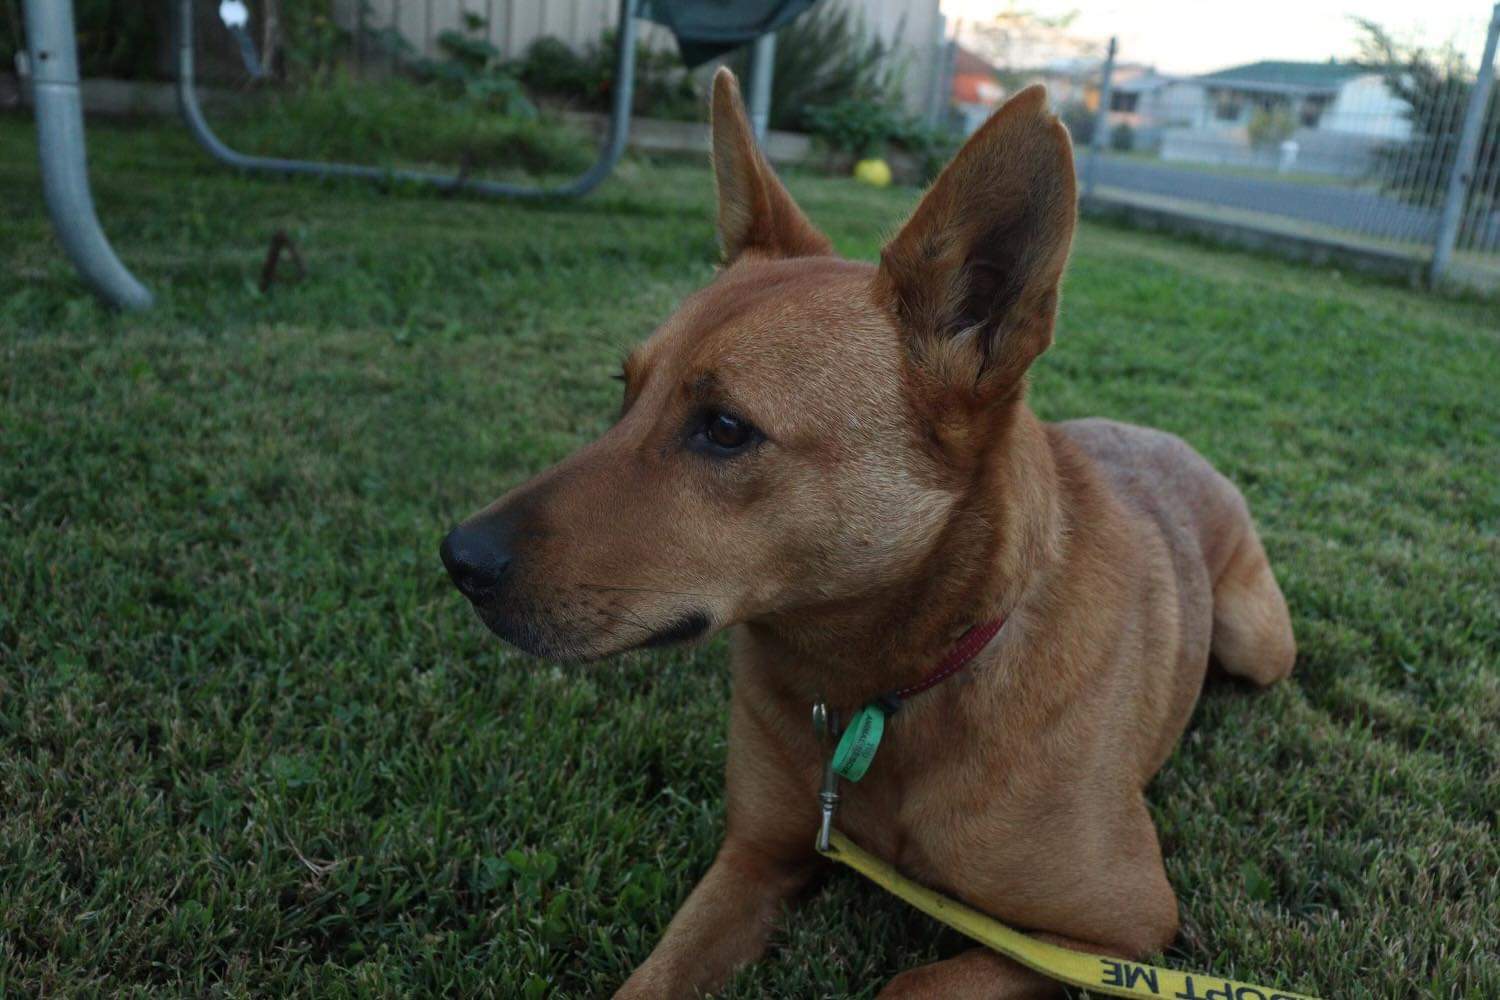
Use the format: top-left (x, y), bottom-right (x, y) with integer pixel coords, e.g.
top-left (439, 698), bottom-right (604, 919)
top-left (615, 834), bottom-right (816, 1000)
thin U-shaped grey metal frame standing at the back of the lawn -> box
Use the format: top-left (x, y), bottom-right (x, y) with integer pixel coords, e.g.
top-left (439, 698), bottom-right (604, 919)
top-left (174, 0), bottom-right (641, 199)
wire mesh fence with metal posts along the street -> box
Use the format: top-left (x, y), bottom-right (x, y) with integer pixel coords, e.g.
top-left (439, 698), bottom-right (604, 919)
top-left (1083, 4), bottom-right (1500, 286)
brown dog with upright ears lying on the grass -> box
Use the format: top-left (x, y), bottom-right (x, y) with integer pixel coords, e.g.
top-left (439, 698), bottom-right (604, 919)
top-left (443, 70), bottom-right (1295, 997)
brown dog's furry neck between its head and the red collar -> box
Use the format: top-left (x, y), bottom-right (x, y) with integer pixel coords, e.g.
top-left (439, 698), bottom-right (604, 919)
top-left (744, 400), bottom-right (1064, 708)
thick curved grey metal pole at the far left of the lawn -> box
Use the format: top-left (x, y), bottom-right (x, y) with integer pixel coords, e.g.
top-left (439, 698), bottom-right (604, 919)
top-left (26, 0), bottom-right (152, 309)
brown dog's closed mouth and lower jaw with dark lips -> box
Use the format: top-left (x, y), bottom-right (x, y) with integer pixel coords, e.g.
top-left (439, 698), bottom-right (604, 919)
top-left (474, 601), bottom-right (713, 663)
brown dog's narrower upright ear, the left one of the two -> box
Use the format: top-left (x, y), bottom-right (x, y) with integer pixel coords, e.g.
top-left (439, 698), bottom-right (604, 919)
top-left (713, 67), bottom-right (834, 264)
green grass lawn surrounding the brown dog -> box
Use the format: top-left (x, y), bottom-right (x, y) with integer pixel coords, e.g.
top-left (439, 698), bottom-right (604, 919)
top-left (0, 118), bottom-right (1500, 999)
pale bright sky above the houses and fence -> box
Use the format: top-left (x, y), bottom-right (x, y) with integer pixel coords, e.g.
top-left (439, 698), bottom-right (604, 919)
top-left (942, 0), bottom-right (1493, 73)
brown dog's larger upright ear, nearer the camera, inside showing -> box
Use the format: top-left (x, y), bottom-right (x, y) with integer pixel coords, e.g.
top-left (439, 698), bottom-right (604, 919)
top-left (876, 87), bottom-right (1077, 399)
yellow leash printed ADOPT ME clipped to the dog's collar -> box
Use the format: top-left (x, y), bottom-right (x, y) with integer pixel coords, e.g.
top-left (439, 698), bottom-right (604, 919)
top-left (821, 831), bottom-right (1317, 1000)
